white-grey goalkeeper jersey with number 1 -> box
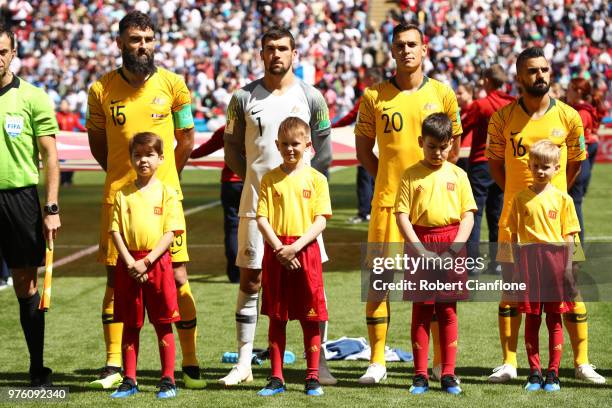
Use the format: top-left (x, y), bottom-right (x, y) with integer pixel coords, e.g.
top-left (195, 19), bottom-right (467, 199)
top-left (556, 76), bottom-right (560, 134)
top-left (223, 78), bottom-right (331, 217)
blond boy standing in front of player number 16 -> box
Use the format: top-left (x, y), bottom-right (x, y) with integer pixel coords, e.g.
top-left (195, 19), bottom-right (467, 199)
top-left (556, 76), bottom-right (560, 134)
top-left (508, 140), bottom-right (580, 392)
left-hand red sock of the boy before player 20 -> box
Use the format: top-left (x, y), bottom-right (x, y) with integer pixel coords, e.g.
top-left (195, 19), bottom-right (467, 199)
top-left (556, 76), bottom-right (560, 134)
top-left (410, 302), bottom-right (442, 378)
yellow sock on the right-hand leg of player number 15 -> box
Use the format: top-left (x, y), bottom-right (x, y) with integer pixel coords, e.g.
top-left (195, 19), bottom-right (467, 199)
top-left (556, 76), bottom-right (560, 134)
top-left (176, 282), bottom-right (199, 367)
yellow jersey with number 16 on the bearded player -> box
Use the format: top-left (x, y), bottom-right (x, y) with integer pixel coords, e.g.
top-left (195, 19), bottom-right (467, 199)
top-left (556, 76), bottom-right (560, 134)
top-left (486, 99), bottom-right (586, 198)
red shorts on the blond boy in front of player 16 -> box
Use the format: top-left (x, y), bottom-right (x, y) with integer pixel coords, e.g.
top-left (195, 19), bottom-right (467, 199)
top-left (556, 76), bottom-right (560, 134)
top-left (515, 244), bottom-right (574, 314)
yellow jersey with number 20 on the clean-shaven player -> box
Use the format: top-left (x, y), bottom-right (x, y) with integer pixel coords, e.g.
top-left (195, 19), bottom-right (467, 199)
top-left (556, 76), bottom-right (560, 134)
top-left (355, 77), bottom-right (463, 207)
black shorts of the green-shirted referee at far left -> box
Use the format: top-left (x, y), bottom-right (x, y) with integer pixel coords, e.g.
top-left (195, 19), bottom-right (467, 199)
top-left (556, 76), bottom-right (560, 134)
top-left (0, 186), bottom-right (45, 268)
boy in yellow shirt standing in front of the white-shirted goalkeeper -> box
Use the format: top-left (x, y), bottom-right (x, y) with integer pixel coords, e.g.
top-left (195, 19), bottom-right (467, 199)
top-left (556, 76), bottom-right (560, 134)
top-left (257, 117), bottom-right (331, 396)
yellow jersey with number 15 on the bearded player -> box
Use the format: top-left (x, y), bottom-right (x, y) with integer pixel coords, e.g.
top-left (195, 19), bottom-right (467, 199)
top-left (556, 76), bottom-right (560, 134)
top-left (87, 68), bottom-right (191, 204)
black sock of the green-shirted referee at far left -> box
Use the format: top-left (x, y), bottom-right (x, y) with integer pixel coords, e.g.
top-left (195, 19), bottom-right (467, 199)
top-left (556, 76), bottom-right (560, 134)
top-left (18, 292), bottom-right (45, 373)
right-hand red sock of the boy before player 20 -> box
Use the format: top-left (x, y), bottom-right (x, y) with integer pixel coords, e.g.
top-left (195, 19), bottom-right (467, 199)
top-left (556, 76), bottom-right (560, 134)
top-left (435, 302), bottom-right (459, 376)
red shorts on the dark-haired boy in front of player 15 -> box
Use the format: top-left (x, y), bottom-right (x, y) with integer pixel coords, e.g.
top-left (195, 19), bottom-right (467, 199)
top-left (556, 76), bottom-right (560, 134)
top-left (114, 251), bottom-right (181, 328)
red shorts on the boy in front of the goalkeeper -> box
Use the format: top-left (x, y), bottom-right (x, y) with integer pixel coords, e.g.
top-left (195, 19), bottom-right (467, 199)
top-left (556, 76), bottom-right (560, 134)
top-left (261, 237), bottom-right (327, 322)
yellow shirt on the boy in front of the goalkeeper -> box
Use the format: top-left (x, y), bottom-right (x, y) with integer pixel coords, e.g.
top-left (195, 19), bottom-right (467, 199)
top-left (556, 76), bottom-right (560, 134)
top-left (257, 166), bottom-right (331, 237)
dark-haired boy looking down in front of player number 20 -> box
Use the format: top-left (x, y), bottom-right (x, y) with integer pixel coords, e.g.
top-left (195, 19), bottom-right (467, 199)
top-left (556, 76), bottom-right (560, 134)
top-left (395, 113), bottom-right (477, 394)
